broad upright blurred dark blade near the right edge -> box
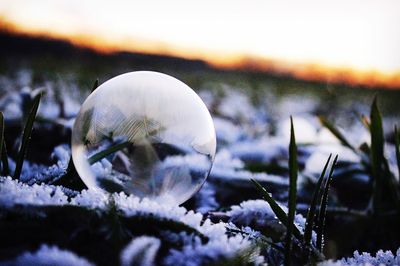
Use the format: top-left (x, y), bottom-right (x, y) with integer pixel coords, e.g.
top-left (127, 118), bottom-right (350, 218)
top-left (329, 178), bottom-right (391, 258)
top-left (370, 97), bottom-right (385, 212)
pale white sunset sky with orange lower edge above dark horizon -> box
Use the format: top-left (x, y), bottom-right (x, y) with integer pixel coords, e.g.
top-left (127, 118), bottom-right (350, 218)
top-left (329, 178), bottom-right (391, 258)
top-left (0, 0), bottom-right (400, 86)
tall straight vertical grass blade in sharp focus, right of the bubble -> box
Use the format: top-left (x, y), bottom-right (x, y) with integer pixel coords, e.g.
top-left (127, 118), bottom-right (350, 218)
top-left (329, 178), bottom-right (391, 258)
top-left (285, 117), bottom-right (299, 265)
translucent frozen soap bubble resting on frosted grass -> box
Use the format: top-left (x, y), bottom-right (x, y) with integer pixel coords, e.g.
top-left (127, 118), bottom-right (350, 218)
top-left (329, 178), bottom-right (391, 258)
top-left (72, 71), bottom-right (216, 204)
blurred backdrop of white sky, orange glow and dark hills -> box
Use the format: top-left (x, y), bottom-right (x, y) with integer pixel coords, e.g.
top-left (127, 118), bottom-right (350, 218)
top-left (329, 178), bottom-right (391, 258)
top-left (0, 0), bottom-right (400, 89)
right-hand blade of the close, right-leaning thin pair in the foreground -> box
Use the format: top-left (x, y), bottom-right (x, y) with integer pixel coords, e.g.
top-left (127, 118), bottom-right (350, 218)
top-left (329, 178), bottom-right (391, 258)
top-left (317, 155), bottom-right (338, 252)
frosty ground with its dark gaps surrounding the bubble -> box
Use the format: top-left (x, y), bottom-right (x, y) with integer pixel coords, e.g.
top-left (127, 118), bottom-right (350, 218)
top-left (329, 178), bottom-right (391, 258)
top-left (0, 71), bottom-right (400, 265)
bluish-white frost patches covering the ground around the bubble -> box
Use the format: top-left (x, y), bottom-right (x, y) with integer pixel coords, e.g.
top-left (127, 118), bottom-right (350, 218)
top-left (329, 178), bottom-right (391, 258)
top-left (0, 70), bottom-right (400, 265)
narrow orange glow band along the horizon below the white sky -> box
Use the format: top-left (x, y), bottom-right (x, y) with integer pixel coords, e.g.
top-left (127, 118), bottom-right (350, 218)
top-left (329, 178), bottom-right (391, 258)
top-left (0, 16), bottom-right (400, 89)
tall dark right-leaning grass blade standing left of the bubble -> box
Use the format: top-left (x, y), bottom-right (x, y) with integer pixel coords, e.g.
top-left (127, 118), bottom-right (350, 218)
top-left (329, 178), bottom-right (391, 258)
top-left (13, 93), bottom-right (42, 179)
